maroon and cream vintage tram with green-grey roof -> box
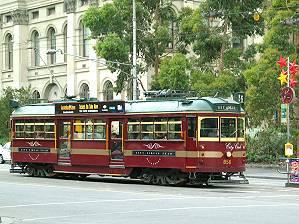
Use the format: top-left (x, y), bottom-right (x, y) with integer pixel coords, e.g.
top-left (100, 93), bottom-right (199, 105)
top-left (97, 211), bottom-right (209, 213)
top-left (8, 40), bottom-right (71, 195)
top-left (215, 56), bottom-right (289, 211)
top-left (11, 97), bottom-right (247, 185)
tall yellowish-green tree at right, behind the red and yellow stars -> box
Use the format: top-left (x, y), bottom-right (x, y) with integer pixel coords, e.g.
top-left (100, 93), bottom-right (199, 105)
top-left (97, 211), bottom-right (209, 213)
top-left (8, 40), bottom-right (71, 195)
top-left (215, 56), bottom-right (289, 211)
top-left (244, 0), bottom-right (299, 126)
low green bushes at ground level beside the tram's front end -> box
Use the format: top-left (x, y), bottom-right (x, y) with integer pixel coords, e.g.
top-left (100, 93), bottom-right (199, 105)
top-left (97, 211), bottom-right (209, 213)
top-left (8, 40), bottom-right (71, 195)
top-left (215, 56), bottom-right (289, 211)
top-left (246, 126), bottom-right (296, 163)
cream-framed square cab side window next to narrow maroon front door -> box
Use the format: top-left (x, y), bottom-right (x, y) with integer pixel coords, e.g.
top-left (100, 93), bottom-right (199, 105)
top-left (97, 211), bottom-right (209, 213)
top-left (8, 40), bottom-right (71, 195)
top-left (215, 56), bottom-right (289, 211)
top-left (200, 118), bottom-right (219, 138)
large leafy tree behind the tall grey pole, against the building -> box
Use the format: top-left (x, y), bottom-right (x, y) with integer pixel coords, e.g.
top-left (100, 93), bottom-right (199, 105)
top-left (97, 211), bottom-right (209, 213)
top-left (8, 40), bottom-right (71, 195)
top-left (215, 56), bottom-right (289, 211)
top-left (84, 0), bottom-right (190, 95)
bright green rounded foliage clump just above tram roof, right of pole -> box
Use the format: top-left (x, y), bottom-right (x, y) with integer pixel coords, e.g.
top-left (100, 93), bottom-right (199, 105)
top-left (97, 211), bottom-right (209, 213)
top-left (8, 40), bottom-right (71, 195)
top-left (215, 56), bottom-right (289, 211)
top-left (152, 54), bottom-right (190, 90)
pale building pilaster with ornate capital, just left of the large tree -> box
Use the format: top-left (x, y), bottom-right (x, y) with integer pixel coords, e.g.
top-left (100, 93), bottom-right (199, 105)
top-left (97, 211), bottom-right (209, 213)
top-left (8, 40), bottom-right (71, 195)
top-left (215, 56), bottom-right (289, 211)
top-left (64, 0), bottom-right (76, 96)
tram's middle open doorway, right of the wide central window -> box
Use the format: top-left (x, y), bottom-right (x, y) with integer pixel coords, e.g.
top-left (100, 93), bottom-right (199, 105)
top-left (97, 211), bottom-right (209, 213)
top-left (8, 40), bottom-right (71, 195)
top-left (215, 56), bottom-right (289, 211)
top-left (109, 120), bottom-right (124, 162)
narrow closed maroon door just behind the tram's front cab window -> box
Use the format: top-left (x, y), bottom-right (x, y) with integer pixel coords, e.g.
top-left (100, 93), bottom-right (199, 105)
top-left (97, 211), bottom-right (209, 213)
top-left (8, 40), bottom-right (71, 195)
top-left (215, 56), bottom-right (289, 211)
top-left (186, 116), bottom-right (198, 168)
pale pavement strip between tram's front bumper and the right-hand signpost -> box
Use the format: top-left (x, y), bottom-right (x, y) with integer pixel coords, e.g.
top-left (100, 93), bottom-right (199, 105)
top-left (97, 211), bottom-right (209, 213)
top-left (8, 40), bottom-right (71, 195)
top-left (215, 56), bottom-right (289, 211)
top-left (244, 164), bottom-right (287, 180)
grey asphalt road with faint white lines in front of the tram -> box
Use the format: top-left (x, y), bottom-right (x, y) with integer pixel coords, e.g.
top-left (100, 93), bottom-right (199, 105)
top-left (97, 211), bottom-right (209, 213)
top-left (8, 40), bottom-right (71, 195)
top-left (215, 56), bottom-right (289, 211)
top-left (0, 164), bottom-right (299, 224)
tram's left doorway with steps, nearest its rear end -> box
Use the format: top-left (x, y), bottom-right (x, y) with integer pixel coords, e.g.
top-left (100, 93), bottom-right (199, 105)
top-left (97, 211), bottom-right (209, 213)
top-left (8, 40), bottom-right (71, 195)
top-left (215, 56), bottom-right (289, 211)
top-left (57, 120), bottom-right (72, 164)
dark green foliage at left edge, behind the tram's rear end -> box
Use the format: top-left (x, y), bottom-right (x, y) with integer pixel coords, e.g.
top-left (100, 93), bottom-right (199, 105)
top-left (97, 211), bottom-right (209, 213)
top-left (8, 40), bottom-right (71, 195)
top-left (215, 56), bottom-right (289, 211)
top-left (0, 86), bottom-right (31, 142)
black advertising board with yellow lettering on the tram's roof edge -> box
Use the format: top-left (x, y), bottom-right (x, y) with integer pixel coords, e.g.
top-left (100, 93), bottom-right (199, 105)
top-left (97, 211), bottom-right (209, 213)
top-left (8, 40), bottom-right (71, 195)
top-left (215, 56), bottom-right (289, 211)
top-left (55, 101), bottom-right (125, 114)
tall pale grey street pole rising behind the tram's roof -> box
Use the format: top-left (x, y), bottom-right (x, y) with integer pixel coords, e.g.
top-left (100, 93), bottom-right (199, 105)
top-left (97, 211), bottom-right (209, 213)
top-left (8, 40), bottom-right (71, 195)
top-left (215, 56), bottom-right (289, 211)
top-left (132, 0), bottom-right (138, 100)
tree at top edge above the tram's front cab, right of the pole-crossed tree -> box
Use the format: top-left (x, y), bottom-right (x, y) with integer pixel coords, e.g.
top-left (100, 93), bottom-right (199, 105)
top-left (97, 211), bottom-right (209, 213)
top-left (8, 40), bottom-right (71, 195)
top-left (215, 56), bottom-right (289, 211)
top-left (182, 0), bottom-right (264, 73)
